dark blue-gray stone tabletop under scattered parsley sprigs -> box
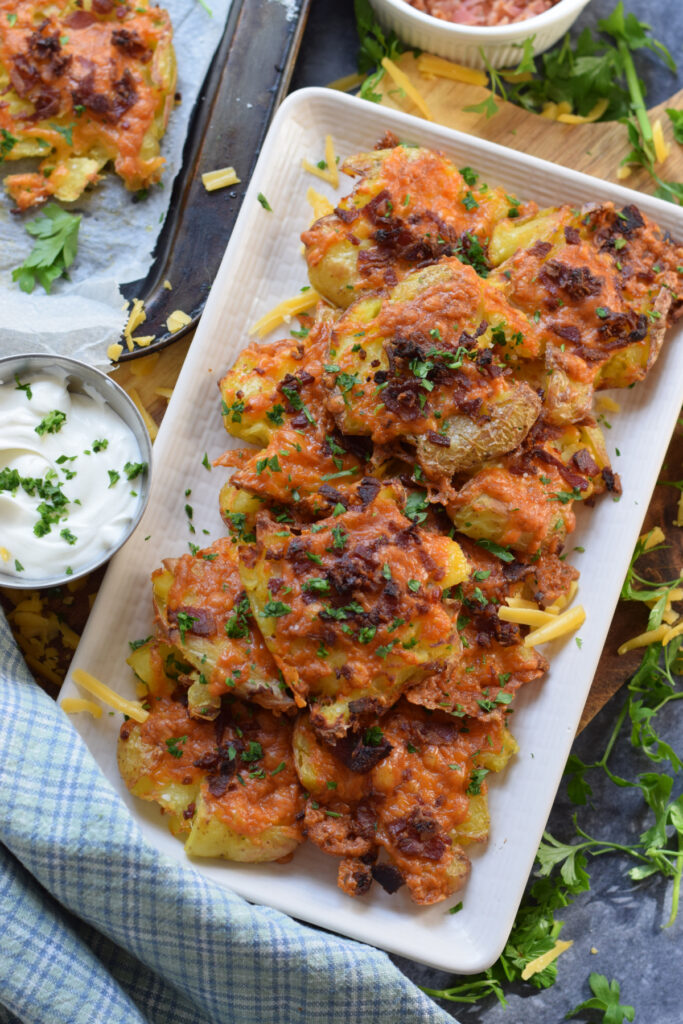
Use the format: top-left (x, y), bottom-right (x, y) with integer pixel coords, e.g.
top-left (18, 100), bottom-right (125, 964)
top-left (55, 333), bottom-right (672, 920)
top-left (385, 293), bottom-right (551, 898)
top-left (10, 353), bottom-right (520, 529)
top-left (292, 0), bottom-right (683, 1024)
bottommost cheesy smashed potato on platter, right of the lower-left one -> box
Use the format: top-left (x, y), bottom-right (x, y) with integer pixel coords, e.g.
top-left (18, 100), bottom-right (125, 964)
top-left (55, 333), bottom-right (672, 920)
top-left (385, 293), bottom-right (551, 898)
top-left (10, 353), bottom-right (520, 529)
top-left (293, 700), bottom-right (516, 904)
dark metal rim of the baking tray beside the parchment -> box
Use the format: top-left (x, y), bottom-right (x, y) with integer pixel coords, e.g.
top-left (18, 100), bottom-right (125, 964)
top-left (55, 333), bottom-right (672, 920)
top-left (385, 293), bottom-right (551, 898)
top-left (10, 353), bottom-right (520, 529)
top-left (120, 0), bottom-right (311, 362)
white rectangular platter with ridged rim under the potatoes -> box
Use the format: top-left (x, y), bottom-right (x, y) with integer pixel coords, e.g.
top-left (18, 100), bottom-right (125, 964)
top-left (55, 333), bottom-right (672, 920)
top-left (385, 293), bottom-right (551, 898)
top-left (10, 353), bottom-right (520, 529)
top-left (58, 89), bottom-right (683, 973)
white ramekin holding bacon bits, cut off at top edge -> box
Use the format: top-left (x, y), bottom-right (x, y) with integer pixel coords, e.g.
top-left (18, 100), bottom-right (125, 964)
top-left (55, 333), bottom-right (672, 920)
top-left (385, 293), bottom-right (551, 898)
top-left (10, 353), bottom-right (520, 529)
top-left (370, 0), bottom-right (589, 68)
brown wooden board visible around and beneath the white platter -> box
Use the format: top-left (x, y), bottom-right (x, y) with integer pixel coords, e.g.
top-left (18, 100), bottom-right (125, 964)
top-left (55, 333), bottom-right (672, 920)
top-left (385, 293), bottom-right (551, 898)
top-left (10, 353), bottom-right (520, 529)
top-left (0, 70), bottom-right (683, 730)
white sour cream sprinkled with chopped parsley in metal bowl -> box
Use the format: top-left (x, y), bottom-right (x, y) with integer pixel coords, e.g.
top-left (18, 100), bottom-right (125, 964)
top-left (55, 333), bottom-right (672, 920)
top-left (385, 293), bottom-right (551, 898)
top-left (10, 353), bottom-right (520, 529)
top-left (0, 371), bottom-right (147, 580)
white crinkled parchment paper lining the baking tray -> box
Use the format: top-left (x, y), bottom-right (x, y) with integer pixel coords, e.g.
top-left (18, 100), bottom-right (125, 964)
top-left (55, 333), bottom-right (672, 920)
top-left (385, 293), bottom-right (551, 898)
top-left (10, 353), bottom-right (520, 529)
top-left (0, 0), bottom-right (236, 368)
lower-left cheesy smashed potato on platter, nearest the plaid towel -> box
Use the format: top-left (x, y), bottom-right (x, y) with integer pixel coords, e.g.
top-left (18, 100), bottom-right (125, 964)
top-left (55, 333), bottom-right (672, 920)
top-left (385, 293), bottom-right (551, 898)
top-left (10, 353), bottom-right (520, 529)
top-left (118, 697), bottom-right (303, 863)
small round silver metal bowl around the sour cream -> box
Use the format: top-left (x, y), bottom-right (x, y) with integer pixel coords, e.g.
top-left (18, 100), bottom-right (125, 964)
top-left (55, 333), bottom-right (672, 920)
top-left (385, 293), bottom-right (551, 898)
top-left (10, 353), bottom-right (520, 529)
top-left (0, 352), bottom-right (152, 590)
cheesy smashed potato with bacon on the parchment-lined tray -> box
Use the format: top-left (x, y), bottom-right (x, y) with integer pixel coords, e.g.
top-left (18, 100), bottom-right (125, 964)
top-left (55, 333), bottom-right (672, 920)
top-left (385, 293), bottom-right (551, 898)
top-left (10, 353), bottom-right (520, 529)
top-left (0, 0), bottom-right (176, 210)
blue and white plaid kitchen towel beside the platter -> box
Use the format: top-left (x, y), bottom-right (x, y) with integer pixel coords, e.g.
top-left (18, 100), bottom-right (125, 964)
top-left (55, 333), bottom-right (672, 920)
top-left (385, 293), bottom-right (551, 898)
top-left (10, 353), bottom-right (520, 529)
top-left (0, 611), bottom-right (453, 1024)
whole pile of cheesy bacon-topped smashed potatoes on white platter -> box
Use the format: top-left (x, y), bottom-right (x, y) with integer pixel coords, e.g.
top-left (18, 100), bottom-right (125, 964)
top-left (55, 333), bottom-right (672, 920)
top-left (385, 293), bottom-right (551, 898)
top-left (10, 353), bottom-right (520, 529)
top-left (119, 137), bottom-right (683, 904)
